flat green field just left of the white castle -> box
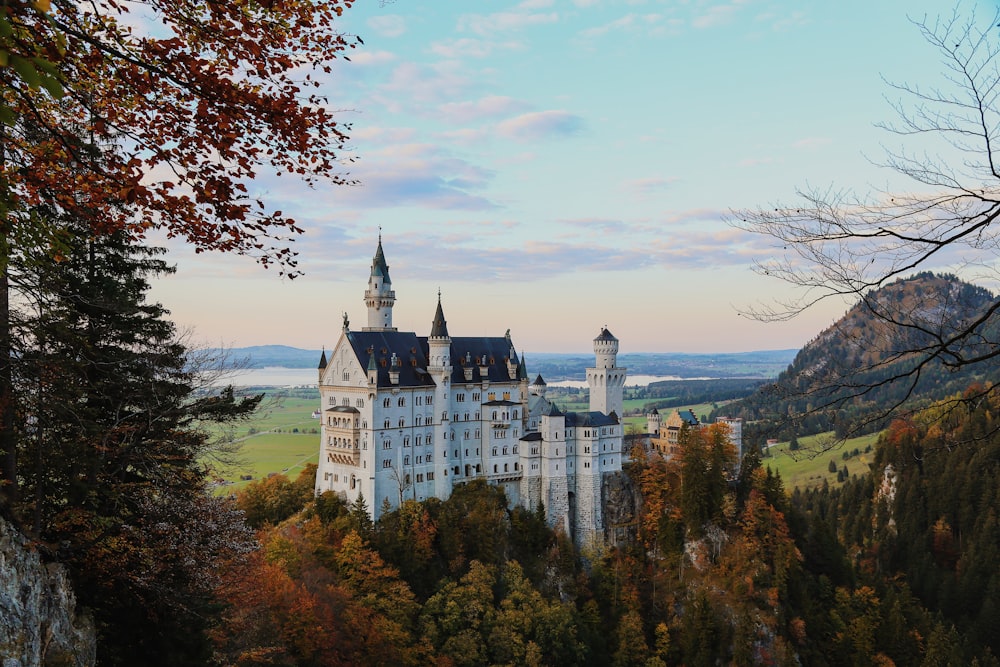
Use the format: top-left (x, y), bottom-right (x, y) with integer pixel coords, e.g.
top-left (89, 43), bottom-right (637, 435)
top-left (207, 397), bottom-right (319, 491)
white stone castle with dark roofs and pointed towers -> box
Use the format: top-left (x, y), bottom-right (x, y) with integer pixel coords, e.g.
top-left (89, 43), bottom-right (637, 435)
top-left (316, 237), bottom-right (626, 545)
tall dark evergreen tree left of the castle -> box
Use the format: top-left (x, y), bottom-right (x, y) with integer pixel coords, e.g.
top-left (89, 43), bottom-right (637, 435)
top-left (20, 222), bottom-right (260, 664)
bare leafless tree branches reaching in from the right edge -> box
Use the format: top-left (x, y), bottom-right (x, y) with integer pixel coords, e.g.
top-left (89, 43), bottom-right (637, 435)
top-left (730, 10), bottom-right (1000, 430)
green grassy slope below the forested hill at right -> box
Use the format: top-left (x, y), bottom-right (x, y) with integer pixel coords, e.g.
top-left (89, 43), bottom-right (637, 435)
top-left (761, 432), bottom-right (879, 492)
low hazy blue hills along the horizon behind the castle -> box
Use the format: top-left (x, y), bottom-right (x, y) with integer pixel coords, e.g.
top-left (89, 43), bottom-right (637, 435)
top-left (219, 345), bottom-right (796, 381)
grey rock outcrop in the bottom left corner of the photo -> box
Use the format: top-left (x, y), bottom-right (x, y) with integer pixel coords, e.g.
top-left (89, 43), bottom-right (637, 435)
top-left (0, 519), bottom-right (97, 667)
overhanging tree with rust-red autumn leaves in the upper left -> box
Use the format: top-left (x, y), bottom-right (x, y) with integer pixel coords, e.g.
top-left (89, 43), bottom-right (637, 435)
top-left (0, 0), bottom-right (355, 512)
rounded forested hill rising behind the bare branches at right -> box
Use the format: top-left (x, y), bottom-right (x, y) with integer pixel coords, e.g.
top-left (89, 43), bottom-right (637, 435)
top-left (719, 273), bottom-right (1000, 439)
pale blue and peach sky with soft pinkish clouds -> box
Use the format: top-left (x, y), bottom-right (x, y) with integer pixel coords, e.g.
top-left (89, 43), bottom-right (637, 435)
top-left (151, 0), bottom-right (984, 358)
